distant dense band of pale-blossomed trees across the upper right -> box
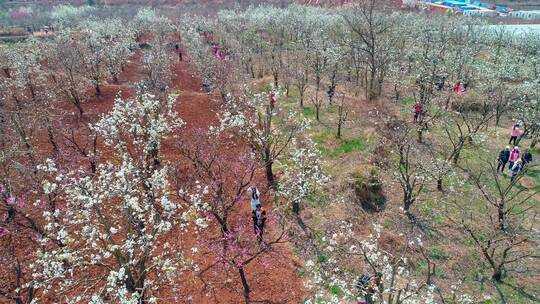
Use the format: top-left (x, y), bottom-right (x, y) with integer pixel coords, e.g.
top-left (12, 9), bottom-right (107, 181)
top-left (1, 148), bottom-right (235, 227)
top-left (201, 1), bottom-right (538, 144)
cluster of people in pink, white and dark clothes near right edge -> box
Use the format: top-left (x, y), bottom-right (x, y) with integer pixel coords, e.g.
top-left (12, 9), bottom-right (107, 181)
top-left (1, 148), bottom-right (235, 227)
top-left (497, 124), bottom-right (532, 181)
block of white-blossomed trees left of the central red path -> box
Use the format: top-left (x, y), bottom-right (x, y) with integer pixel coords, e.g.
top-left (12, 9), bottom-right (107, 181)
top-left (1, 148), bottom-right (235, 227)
top-left (0, 6), bottom-right (198, 303)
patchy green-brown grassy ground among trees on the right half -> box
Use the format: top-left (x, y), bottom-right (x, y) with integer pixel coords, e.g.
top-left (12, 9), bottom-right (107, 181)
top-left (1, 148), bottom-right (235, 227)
top-left (274, 80), bottom-right (540, 304)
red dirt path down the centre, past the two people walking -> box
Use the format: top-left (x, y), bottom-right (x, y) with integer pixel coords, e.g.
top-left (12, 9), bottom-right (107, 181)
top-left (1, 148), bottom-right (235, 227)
top-left (167, 56), bottom-right (304, 304)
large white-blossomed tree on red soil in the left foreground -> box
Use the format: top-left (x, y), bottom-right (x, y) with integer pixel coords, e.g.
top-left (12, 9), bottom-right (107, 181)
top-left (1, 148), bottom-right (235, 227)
top-left (32, 90), bottom-right (196, 303)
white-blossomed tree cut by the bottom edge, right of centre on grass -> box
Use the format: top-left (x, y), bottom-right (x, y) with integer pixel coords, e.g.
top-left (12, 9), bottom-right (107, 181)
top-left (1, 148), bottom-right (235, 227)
top-left (305, 222), bottom-right (472, 304)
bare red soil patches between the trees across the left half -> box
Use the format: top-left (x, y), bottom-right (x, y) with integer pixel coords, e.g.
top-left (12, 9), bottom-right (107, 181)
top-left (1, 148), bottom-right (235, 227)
top-left (0, 41), bottom-right (305, 303)
